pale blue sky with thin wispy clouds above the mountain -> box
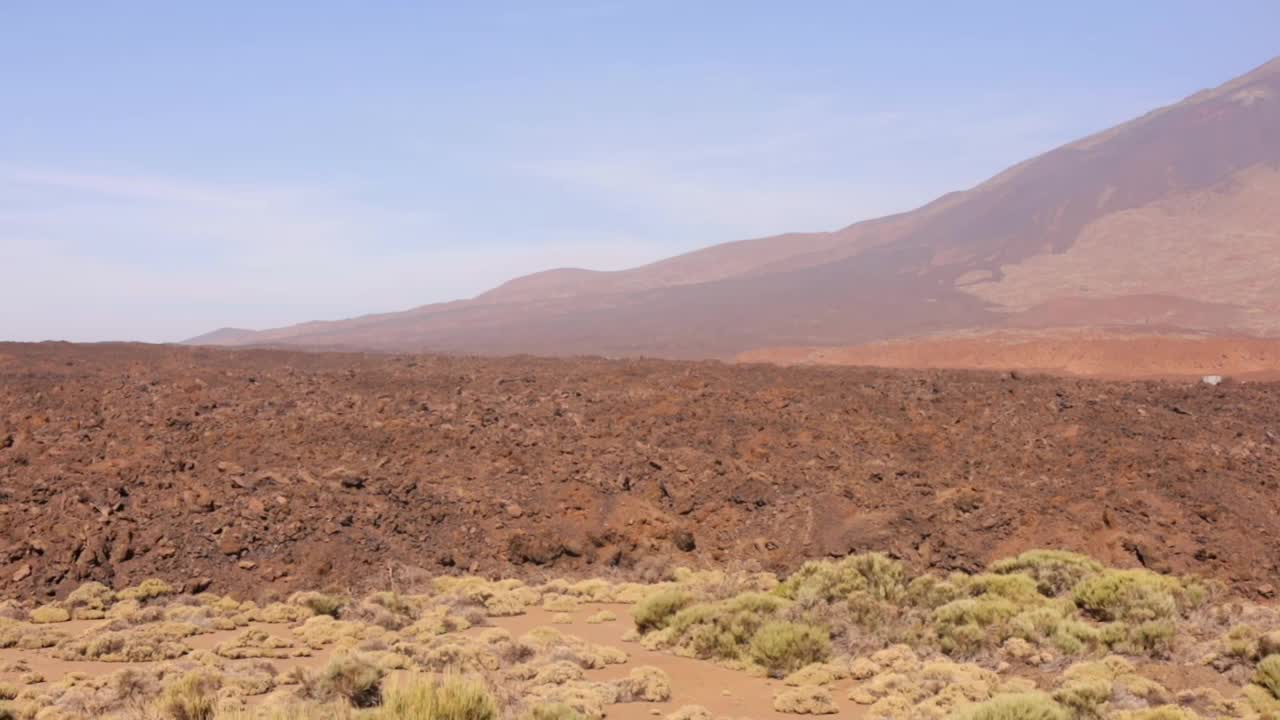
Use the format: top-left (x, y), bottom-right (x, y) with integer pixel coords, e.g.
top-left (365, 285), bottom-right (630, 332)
top-left (0, 0), bottom-right (1280, 342)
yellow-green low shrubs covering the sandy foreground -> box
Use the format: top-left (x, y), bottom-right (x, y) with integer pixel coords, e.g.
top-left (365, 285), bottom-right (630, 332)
top-left (0, 551), bottom-right (1280, 720)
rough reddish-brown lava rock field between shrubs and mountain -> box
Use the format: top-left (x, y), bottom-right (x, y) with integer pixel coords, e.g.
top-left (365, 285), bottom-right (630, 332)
top-left (0, 343), bottom-right (1280, 600)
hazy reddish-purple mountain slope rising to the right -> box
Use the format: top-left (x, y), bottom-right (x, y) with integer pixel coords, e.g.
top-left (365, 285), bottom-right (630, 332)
top-left (189, 59), bottom-right (1280, 357)
